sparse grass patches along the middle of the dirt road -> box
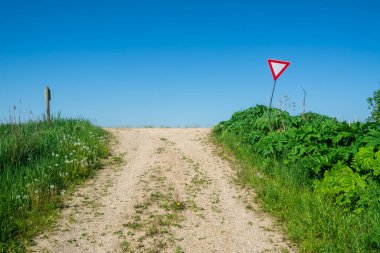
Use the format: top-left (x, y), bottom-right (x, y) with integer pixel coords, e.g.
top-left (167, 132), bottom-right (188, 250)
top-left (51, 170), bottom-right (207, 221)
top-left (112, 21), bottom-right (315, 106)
top-left (123, 157), bottom-right (188, 252)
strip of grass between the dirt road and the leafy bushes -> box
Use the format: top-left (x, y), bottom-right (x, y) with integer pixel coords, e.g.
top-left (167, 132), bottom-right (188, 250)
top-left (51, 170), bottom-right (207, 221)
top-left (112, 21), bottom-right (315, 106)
top-left (214, 134), bottom-right (380, 253)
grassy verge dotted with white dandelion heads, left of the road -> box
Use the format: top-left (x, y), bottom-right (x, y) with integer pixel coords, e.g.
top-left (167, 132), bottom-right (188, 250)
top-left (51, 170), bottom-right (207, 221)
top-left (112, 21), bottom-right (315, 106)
top-left (0, 119), bottom-right (109, 252)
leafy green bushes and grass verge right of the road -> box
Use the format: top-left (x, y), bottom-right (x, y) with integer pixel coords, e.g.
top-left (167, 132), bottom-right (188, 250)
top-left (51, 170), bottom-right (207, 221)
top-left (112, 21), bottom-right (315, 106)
top-left (213, 90), bottom-right (380, 252)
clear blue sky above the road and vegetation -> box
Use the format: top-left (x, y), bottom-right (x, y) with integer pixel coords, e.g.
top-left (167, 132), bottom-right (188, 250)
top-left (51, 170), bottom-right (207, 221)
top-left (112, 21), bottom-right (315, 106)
top-left (0, 0), bottom-right (380, 126)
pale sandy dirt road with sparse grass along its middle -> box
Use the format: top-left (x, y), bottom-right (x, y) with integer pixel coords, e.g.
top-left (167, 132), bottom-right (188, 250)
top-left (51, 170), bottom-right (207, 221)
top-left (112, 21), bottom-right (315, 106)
top-left (31, 128), bottom-right (296, 253)
